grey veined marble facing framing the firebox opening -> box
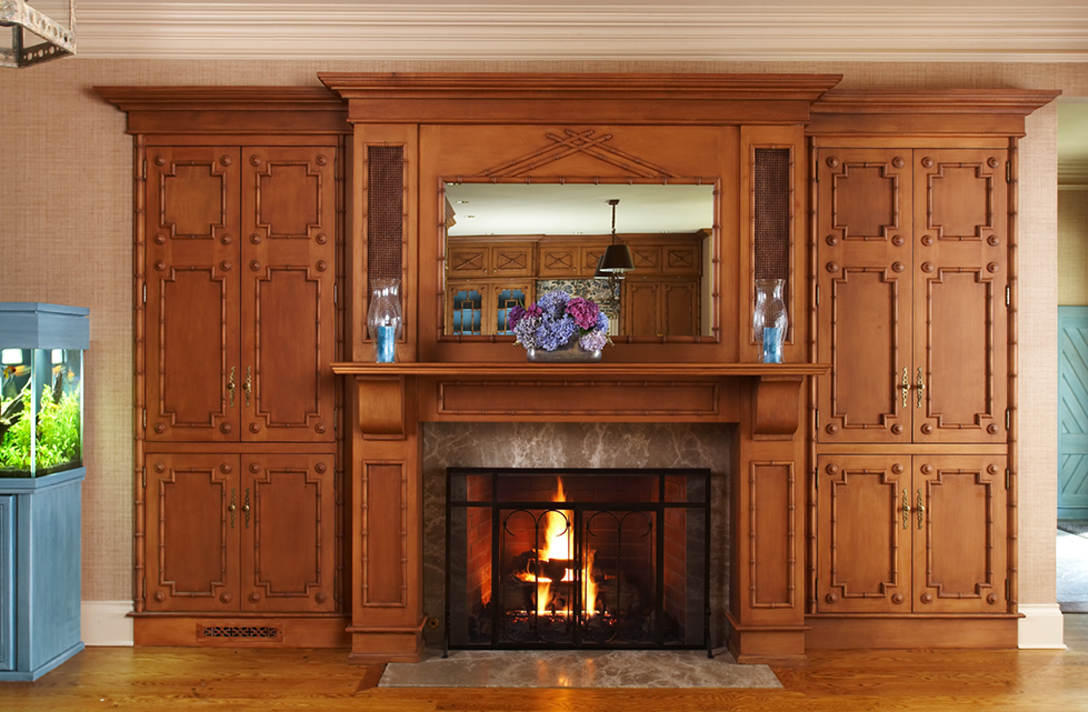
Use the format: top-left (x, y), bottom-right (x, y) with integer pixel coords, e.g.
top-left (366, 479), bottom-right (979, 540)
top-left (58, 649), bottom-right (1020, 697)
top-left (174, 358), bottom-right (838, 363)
top-left (422, 422), bottom-right (733, 648)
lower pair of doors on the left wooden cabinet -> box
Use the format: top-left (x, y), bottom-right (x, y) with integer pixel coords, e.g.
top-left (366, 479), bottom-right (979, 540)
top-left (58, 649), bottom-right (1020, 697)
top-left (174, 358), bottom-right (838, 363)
top-left (146, 453), bottom-right (336, 613)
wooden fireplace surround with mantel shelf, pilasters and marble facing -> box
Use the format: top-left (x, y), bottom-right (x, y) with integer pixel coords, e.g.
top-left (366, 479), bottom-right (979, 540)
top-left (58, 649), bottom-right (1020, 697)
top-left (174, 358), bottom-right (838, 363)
top-left (333, 361), bottom-right (826, 663)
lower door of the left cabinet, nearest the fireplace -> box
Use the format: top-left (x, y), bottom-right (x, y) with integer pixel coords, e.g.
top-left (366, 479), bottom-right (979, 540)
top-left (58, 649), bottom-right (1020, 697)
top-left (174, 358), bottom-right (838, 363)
top-left (238, 455), bottom-right (336, 612)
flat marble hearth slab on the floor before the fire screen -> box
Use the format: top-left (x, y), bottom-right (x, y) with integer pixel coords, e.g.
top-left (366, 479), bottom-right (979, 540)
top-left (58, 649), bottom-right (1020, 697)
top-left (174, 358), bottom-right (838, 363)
top-left (378, 650), bottom-right (782, 688)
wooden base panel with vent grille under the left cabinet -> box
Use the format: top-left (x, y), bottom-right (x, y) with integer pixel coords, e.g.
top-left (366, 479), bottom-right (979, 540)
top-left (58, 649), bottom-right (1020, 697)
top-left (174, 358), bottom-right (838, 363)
top-left (133, 614), bottom-right (351, 648)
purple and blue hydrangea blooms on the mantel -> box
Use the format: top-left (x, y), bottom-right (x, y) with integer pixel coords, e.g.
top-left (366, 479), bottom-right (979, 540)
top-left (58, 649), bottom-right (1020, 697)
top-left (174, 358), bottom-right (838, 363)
top-left (507, 290), bottom-right (611, 352)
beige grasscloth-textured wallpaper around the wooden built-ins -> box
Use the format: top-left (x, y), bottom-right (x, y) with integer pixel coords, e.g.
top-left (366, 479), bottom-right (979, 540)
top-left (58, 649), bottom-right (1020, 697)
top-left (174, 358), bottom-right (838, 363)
top-left (0, 58), bottom-right (1074, 603)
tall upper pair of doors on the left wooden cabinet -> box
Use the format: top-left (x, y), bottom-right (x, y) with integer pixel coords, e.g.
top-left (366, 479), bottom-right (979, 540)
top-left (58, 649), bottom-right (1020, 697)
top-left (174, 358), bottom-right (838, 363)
top-left (145, 146), bottom-right (336, 443)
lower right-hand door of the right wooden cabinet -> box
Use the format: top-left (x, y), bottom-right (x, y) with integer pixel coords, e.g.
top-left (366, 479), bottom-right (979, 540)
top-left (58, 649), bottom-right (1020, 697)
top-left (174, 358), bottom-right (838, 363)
top-left (911, 455), bottom-right (1007, 613)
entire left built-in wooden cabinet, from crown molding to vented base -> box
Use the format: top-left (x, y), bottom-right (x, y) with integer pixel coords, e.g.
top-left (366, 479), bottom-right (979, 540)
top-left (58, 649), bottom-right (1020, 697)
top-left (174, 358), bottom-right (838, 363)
top-left (96, 87), bottom-right (348, 647)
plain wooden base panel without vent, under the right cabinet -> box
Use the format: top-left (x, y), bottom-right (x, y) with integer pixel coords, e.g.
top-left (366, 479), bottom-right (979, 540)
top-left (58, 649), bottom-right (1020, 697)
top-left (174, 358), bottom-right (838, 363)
top-left (805, 615), bottom-right (1019, 651)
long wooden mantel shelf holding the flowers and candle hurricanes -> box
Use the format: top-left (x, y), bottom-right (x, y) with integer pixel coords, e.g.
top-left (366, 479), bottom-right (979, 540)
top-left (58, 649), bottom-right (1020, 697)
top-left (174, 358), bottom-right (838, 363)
top-left (332, 361), bottom-right (830, 379)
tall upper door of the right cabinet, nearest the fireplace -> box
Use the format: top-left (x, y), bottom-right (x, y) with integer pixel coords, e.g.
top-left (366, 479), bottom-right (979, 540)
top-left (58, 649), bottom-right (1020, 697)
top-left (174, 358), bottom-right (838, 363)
top-left (816, 149), bottom-right (913, 443)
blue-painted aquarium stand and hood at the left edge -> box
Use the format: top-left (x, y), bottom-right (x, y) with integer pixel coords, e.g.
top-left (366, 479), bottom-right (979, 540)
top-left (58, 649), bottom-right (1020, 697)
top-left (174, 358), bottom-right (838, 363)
top-left (0, 303), bottom-right (90, 682)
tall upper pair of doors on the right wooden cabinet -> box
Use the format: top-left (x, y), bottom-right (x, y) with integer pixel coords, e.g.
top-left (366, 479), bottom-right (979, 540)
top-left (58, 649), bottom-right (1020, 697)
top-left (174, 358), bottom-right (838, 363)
top-left (816, 147), bottom-right (1009, 443)
